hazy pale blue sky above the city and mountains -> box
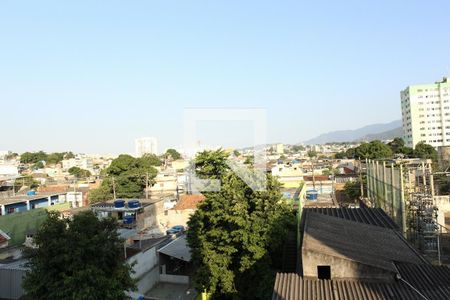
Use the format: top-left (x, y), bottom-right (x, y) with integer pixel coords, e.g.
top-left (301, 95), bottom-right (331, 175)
top-left (0, 0), bottom-right (450, 153)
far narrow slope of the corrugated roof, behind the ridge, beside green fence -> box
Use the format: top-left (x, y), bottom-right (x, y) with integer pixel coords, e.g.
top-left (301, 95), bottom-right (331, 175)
top-left (304, 206), bottom-right (399, 230)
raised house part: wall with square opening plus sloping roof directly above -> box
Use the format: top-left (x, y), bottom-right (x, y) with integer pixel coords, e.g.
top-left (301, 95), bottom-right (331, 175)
top-left (300, 209), bottom-right (428, 280)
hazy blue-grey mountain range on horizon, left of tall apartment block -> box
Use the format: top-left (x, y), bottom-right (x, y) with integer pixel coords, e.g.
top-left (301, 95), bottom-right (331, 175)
top-left (303, 120), bottom-right (402, 144)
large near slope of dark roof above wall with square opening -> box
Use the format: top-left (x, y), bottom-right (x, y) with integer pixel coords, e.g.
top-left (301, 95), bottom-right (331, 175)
top-left (302, 211), bottom-right (428, 272)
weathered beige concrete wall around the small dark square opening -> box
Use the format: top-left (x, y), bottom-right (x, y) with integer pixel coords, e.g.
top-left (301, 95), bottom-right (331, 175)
top-left (302, 249), bottom-right (393, 280)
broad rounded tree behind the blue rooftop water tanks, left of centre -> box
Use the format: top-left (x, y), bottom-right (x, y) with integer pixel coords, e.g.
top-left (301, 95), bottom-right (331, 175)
top-left (89, 154), bottom-right (161, 202)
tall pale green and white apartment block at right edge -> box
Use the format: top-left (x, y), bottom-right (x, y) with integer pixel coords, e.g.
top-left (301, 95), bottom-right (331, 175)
top-left (400, 77), bottom-right (450, 148)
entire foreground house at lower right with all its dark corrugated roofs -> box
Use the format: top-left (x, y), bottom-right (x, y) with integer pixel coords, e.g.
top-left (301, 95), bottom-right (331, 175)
top-left (272, 206), bottom-right (450, 300)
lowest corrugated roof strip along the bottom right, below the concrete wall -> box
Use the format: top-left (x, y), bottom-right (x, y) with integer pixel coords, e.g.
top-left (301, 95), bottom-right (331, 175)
top-left (272, 273), bottom-right (450, 300)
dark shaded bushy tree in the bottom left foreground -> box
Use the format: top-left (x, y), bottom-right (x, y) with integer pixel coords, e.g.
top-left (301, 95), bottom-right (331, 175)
top-left (23, 211), bottom-right (135, 300)
